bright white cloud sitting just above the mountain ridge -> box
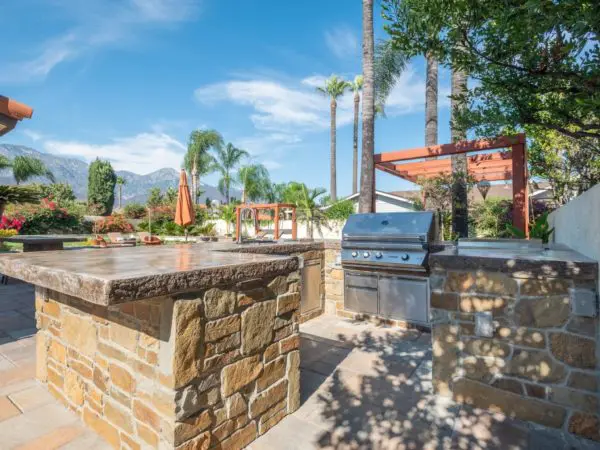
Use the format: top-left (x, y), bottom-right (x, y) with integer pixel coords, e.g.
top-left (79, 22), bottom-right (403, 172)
top-left (44, 133), bottom-right (186, 174)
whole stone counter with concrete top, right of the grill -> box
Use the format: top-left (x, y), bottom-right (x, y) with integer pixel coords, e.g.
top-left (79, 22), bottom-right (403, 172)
top-left (429, 240), bottom-right (600, 441)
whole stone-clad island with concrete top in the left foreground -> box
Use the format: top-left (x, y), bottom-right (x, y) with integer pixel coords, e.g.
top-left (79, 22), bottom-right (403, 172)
top-left (0, 245), bottom-right (300, 450)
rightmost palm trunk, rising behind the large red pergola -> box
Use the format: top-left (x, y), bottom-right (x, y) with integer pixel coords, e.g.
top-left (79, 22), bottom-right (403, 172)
top-left (451, 68), bottom-right (469, 237)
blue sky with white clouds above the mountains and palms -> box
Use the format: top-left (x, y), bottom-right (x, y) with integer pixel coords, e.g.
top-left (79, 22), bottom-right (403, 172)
top-left (0, 0), bottom-right (449, 195)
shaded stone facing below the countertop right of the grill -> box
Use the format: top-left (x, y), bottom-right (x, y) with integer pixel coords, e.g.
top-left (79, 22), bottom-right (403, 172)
top-left (430, 268), bottom-right (600, 441)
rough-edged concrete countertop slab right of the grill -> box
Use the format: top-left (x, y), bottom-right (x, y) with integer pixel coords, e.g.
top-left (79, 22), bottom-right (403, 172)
top-left (429, 245), bottom-right (598, 279)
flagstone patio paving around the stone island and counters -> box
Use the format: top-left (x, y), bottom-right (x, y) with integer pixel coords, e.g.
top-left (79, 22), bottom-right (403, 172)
top-left (0, 280), bottom-right (600, 450)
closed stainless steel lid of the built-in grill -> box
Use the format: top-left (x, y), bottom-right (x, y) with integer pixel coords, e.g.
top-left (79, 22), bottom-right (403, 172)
top-left (342, 211), bottom-right (434, 243)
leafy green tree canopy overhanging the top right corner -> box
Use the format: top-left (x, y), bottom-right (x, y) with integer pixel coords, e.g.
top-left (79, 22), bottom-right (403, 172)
top-left (382, 0), bottom-right (600, 144)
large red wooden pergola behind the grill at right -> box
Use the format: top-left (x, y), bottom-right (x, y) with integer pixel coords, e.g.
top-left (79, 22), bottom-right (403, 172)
top-left (374, 134), bottom-right (529, 235)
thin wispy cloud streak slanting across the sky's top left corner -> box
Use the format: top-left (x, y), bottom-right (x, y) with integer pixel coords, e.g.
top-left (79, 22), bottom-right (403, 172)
top-left (0, 0), bottom-right (200, 83)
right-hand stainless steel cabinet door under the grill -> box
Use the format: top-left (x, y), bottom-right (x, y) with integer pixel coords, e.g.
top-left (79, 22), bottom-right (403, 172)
top-left (379, 275), bottom-right (429, 323)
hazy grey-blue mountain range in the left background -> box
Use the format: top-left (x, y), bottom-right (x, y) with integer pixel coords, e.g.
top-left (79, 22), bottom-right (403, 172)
top-left (0, 144), bottom-right (234, 204)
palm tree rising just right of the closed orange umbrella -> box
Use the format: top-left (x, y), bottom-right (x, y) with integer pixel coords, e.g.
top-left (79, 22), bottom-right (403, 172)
top-left (183, 130), bottom-right (223, 204)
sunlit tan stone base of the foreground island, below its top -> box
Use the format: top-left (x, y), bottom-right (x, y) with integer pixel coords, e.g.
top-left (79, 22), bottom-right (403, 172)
top-left (36, 271), bottom-right (300, 450)
